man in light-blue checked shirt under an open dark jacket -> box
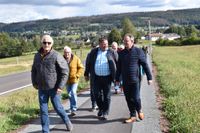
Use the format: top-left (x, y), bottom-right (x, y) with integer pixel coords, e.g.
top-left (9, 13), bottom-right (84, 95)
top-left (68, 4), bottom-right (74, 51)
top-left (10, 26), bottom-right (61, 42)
top-left (84, 37), bottom-right (118, 120)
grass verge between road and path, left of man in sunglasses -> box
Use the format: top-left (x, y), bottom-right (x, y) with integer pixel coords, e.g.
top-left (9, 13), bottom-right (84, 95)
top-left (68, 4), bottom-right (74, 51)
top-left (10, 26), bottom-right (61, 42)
top-left (0, 88), bottom-right (39, 133)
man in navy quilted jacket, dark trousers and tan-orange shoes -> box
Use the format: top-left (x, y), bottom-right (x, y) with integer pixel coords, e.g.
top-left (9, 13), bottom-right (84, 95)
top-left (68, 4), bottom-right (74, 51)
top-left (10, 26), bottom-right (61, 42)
top-left (116, 34), bottom-right (152, 123)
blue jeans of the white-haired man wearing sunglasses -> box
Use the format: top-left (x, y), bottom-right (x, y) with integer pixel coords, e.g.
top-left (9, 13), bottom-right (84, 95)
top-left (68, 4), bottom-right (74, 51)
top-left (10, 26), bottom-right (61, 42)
top-left (38, 89), bottom-right (70, 133)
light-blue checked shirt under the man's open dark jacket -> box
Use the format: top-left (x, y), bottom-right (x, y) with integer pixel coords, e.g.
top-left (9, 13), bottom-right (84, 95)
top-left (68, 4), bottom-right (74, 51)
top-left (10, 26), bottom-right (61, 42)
top-left (95, 49), bottom-right (110, 76)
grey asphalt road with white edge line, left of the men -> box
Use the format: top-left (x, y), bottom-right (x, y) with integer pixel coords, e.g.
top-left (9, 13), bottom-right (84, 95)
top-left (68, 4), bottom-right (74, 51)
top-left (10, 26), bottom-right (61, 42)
top-left (0, 72), bottom-right (31, 95)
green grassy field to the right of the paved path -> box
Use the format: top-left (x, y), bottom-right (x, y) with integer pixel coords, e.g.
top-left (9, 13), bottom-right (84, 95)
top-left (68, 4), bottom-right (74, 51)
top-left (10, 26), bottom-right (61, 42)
top-left (153, 46), bottom-right (200, 133)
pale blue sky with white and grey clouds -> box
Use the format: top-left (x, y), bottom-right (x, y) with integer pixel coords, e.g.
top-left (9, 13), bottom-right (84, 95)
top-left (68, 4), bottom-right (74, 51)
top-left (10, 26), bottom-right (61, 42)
top-left (0, 0), bottom-right (200, 23)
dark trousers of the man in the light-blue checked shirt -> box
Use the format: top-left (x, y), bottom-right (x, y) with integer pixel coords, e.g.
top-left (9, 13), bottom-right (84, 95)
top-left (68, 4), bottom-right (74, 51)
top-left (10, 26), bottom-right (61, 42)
top-left (94, 76), bottom-right (111, 115)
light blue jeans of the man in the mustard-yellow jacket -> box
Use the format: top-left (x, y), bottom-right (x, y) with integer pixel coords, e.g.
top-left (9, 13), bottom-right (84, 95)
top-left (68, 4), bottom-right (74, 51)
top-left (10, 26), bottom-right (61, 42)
top-left (67, 83), bottom-right (78, 111)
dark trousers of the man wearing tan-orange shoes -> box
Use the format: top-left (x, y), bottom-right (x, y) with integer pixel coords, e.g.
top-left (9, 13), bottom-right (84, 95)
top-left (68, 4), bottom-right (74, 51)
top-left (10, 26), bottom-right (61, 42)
top-left (123, 82), bottom-right (141, 117)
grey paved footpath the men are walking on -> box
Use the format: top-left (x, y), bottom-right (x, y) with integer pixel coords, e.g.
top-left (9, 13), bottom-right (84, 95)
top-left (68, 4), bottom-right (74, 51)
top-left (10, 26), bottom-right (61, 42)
top-left (20, 54), bottom-right (161, 133)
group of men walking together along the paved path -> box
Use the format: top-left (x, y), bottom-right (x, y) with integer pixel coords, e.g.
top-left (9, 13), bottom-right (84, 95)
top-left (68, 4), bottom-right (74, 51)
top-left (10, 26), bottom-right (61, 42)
top-left (31, 34), bottom-right (152, 133)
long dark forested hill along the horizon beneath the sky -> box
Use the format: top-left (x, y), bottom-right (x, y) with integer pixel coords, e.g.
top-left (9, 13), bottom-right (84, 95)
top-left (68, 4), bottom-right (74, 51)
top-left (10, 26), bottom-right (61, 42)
top-left (0, 8), bottom-right (200, 32)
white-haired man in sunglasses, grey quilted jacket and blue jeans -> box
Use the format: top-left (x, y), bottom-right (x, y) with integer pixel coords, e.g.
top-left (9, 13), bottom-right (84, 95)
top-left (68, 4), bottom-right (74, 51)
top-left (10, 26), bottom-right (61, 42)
top-left (31, 35), bottom-right (73, 133)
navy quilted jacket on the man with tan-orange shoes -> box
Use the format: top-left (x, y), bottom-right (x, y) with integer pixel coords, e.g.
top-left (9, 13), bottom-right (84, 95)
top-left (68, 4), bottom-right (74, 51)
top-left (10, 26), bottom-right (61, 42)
top-left (116, 47), bottom-right (152, 84)
